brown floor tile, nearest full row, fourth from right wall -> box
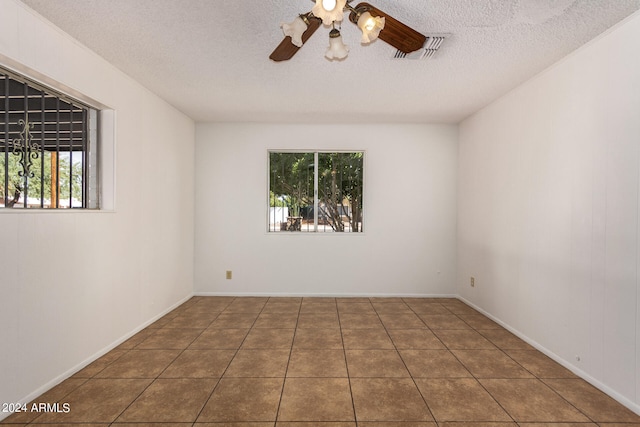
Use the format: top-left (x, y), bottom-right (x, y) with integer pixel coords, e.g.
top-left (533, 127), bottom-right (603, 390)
top-left (351, 378), bottom-right (433, 423)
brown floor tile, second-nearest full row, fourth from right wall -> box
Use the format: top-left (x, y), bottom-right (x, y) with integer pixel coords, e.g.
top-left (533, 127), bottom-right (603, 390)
top-left (346, 350), bottom-right (409, 378)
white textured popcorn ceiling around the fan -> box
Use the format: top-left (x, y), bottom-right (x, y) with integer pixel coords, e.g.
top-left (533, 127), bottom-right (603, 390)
top-left (23, 0), bottom-right (640, 123)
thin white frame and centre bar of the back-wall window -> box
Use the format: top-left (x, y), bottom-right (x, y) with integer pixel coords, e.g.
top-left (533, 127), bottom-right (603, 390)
top-left (266, 149), bottom-right (367, 235)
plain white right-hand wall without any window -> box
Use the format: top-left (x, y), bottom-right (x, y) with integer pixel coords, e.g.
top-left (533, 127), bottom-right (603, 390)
top-left (457, 14), bottom-right (640, 412)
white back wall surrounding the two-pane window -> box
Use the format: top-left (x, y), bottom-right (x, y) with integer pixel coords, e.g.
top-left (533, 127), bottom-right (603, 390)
top-left (195, 124), bottom-right (457, 295)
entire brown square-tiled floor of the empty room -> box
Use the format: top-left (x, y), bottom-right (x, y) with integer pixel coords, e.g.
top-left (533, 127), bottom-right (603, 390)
top-left (4, 297), bottom-right (640, 427)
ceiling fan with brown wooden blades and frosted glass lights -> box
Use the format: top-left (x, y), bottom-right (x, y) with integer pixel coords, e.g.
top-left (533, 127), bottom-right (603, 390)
top-left (269, 0), bottom-right (427, 62)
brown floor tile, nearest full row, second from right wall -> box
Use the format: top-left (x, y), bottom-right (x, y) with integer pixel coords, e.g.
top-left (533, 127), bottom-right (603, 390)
top-left (479, 379), bottom-right (589, 423)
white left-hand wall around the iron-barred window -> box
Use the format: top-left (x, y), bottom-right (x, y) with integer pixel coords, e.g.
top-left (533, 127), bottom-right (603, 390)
top-left (0, 0), bottom-right (195, 417)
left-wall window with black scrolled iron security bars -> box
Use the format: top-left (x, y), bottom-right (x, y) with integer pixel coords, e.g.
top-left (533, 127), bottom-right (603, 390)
top-left (0, 69), bottom-right (98, 209)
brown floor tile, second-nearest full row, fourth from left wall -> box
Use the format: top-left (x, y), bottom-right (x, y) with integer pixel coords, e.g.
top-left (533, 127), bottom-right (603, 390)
top-left (224, 349), bottom-right (290, 378)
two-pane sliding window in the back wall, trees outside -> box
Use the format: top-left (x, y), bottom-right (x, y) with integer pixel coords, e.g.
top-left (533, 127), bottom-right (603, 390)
top-left (269, 151), bottom-right (364, 233)
